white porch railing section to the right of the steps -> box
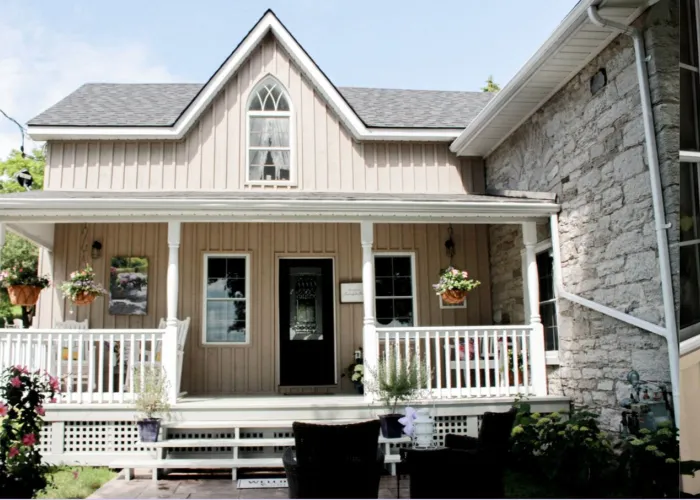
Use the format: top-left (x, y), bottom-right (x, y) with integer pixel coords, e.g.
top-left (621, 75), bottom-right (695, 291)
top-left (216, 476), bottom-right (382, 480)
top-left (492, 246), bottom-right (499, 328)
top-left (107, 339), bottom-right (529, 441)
top-left (376, 325), bottom-right (534, 399)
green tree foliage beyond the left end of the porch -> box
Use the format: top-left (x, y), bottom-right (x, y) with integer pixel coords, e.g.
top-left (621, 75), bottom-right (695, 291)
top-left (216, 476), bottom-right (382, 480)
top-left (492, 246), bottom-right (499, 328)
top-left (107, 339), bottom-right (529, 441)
top-left (0, 149), bottom-right (46, 327)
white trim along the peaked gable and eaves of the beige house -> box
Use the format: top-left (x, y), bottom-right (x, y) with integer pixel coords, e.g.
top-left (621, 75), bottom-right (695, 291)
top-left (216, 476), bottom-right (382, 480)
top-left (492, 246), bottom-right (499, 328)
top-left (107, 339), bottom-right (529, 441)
top-left (28, 10), bottom-right (461, 142)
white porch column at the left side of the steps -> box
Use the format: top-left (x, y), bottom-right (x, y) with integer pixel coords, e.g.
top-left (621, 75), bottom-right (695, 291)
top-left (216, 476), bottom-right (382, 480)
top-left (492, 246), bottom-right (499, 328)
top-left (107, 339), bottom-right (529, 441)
top-left (163, 221), bottom-right (180, 404)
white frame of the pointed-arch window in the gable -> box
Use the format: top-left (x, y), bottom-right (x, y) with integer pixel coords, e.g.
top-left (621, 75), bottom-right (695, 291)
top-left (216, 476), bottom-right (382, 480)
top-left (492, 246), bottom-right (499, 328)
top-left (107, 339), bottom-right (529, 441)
top-left (245, 74), bottom-right (297, 186)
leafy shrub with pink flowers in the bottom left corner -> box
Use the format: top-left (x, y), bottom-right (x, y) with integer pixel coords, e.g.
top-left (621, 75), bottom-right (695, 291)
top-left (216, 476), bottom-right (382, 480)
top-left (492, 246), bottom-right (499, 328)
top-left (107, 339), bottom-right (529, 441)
top-left (0, 366), bottom-right (59, 498)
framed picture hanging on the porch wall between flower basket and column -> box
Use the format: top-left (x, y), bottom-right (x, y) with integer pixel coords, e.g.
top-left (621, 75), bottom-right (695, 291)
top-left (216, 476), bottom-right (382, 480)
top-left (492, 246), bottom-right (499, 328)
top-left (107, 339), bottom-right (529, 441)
top-left (109, 257), bottom-right (148, 316)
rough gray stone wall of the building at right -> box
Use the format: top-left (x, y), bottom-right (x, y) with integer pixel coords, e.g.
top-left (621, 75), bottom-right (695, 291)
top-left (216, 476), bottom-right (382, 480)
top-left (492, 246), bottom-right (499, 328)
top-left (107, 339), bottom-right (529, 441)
top-left (486, 0), bottom-right (679, 428)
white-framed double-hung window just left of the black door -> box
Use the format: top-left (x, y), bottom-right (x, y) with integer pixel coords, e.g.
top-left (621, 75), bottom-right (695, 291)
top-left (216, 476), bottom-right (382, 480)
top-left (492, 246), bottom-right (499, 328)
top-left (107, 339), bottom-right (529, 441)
top-left (202, 254), bottom-right (250, 344)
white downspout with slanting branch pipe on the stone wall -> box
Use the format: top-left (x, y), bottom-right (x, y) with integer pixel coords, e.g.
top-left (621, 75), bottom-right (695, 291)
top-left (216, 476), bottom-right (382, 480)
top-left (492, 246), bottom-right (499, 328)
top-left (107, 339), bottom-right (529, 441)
top-left (550, 6), bottom-right (680, 429)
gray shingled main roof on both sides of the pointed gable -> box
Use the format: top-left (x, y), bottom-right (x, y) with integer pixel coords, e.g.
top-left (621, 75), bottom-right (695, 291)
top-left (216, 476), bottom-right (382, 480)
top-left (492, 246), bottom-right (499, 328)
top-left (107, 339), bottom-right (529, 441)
top-left (29, 83), bottom-right (493, 128)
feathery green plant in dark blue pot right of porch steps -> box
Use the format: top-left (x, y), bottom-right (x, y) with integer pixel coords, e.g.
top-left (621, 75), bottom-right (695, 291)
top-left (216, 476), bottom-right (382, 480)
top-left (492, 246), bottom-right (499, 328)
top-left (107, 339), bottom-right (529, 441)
top-left (375, 352), bottom-right (428, 438)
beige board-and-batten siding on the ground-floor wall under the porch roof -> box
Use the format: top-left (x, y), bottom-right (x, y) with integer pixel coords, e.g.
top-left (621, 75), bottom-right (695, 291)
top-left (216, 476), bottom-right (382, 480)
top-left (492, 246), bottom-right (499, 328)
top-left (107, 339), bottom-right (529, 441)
top-left (38, 223), bottom-right (492, 394)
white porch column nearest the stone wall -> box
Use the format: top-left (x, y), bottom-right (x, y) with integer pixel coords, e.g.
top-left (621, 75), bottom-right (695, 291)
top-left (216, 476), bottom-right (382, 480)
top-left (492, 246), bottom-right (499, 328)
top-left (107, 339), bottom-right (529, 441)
top-left (523, 222), bottom-right (547, 396)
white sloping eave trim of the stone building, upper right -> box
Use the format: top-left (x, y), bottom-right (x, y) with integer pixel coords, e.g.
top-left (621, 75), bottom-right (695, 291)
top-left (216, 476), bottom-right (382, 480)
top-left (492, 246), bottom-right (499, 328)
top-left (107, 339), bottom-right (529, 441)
top-left (450, 0), bottom-right (657, 157)
